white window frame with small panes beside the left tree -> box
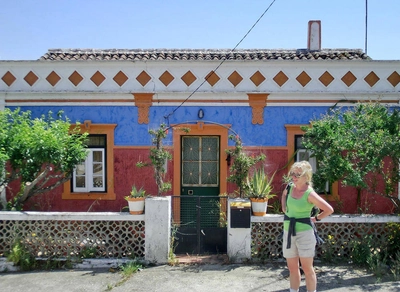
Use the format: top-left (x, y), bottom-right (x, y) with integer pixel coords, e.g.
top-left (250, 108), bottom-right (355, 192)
top-left (72, 148), bottom-right (106, 193)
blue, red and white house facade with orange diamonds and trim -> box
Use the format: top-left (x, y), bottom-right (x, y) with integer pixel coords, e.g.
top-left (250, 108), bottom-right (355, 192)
top-left (0, 41), bottom-right (400, 214)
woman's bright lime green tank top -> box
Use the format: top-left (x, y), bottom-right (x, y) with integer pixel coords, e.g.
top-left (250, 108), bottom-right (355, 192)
top-left (283, 187), bottom-right (314, 232)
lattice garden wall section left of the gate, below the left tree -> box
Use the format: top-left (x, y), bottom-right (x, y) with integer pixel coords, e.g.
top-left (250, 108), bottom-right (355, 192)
top-left (0, 213), bottom-right (145, 258)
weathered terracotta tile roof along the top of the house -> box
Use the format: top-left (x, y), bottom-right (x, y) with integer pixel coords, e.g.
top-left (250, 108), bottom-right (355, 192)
top-left (40, 49), bottom-right (371, 61)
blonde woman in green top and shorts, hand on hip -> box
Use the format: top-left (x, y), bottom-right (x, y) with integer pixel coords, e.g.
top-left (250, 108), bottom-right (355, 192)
top-left (282, 161), bottom-right (333, 292)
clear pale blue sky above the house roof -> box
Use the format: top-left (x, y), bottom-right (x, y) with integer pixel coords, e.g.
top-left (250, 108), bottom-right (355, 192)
top-left (0, 0), bottom-right (400, 60)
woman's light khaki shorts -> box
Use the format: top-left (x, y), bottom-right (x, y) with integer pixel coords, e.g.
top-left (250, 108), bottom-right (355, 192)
top-left (282, 229), bottom-right (317, 259)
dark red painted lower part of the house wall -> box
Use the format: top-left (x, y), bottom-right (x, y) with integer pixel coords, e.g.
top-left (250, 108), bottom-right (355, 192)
top-left (7, 148), bottom-right (393, 214)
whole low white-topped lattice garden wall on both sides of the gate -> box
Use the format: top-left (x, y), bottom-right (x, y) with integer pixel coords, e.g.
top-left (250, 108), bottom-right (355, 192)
top-left (0, 208), bottom-right (400, 263)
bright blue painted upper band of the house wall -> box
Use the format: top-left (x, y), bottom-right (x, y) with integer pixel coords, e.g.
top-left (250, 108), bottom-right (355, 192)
top-left (9, 106), bottom-right (328, 146)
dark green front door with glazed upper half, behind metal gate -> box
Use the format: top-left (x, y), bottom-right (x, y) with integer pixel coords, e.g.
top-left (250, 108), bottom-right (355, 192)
top-left (177, 136), bottom-right (226, 253)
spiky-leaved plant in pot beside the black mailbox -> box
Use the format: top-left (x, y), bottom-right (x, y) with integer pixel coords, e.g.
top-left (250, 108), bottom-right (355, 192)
top-left (246, 168), bottom-right (276, 216)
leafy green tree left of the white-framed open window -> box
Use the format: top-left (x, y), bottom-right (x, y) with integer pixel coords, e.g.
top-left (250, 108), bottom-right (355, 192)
top-left (0, 109), bottom-right (87, 208)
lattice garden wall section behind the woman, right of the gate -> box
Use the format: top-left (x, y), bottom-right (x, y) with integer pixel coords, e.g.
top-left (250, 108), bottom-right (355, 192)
top-left (251, 215), bottom-right (399, 261)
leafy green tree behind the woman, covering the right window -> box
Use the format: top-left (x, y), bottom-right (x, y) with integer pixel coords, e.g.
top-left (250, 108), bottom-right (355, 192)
top-left (303, 102), bottom-right (400, 213)
